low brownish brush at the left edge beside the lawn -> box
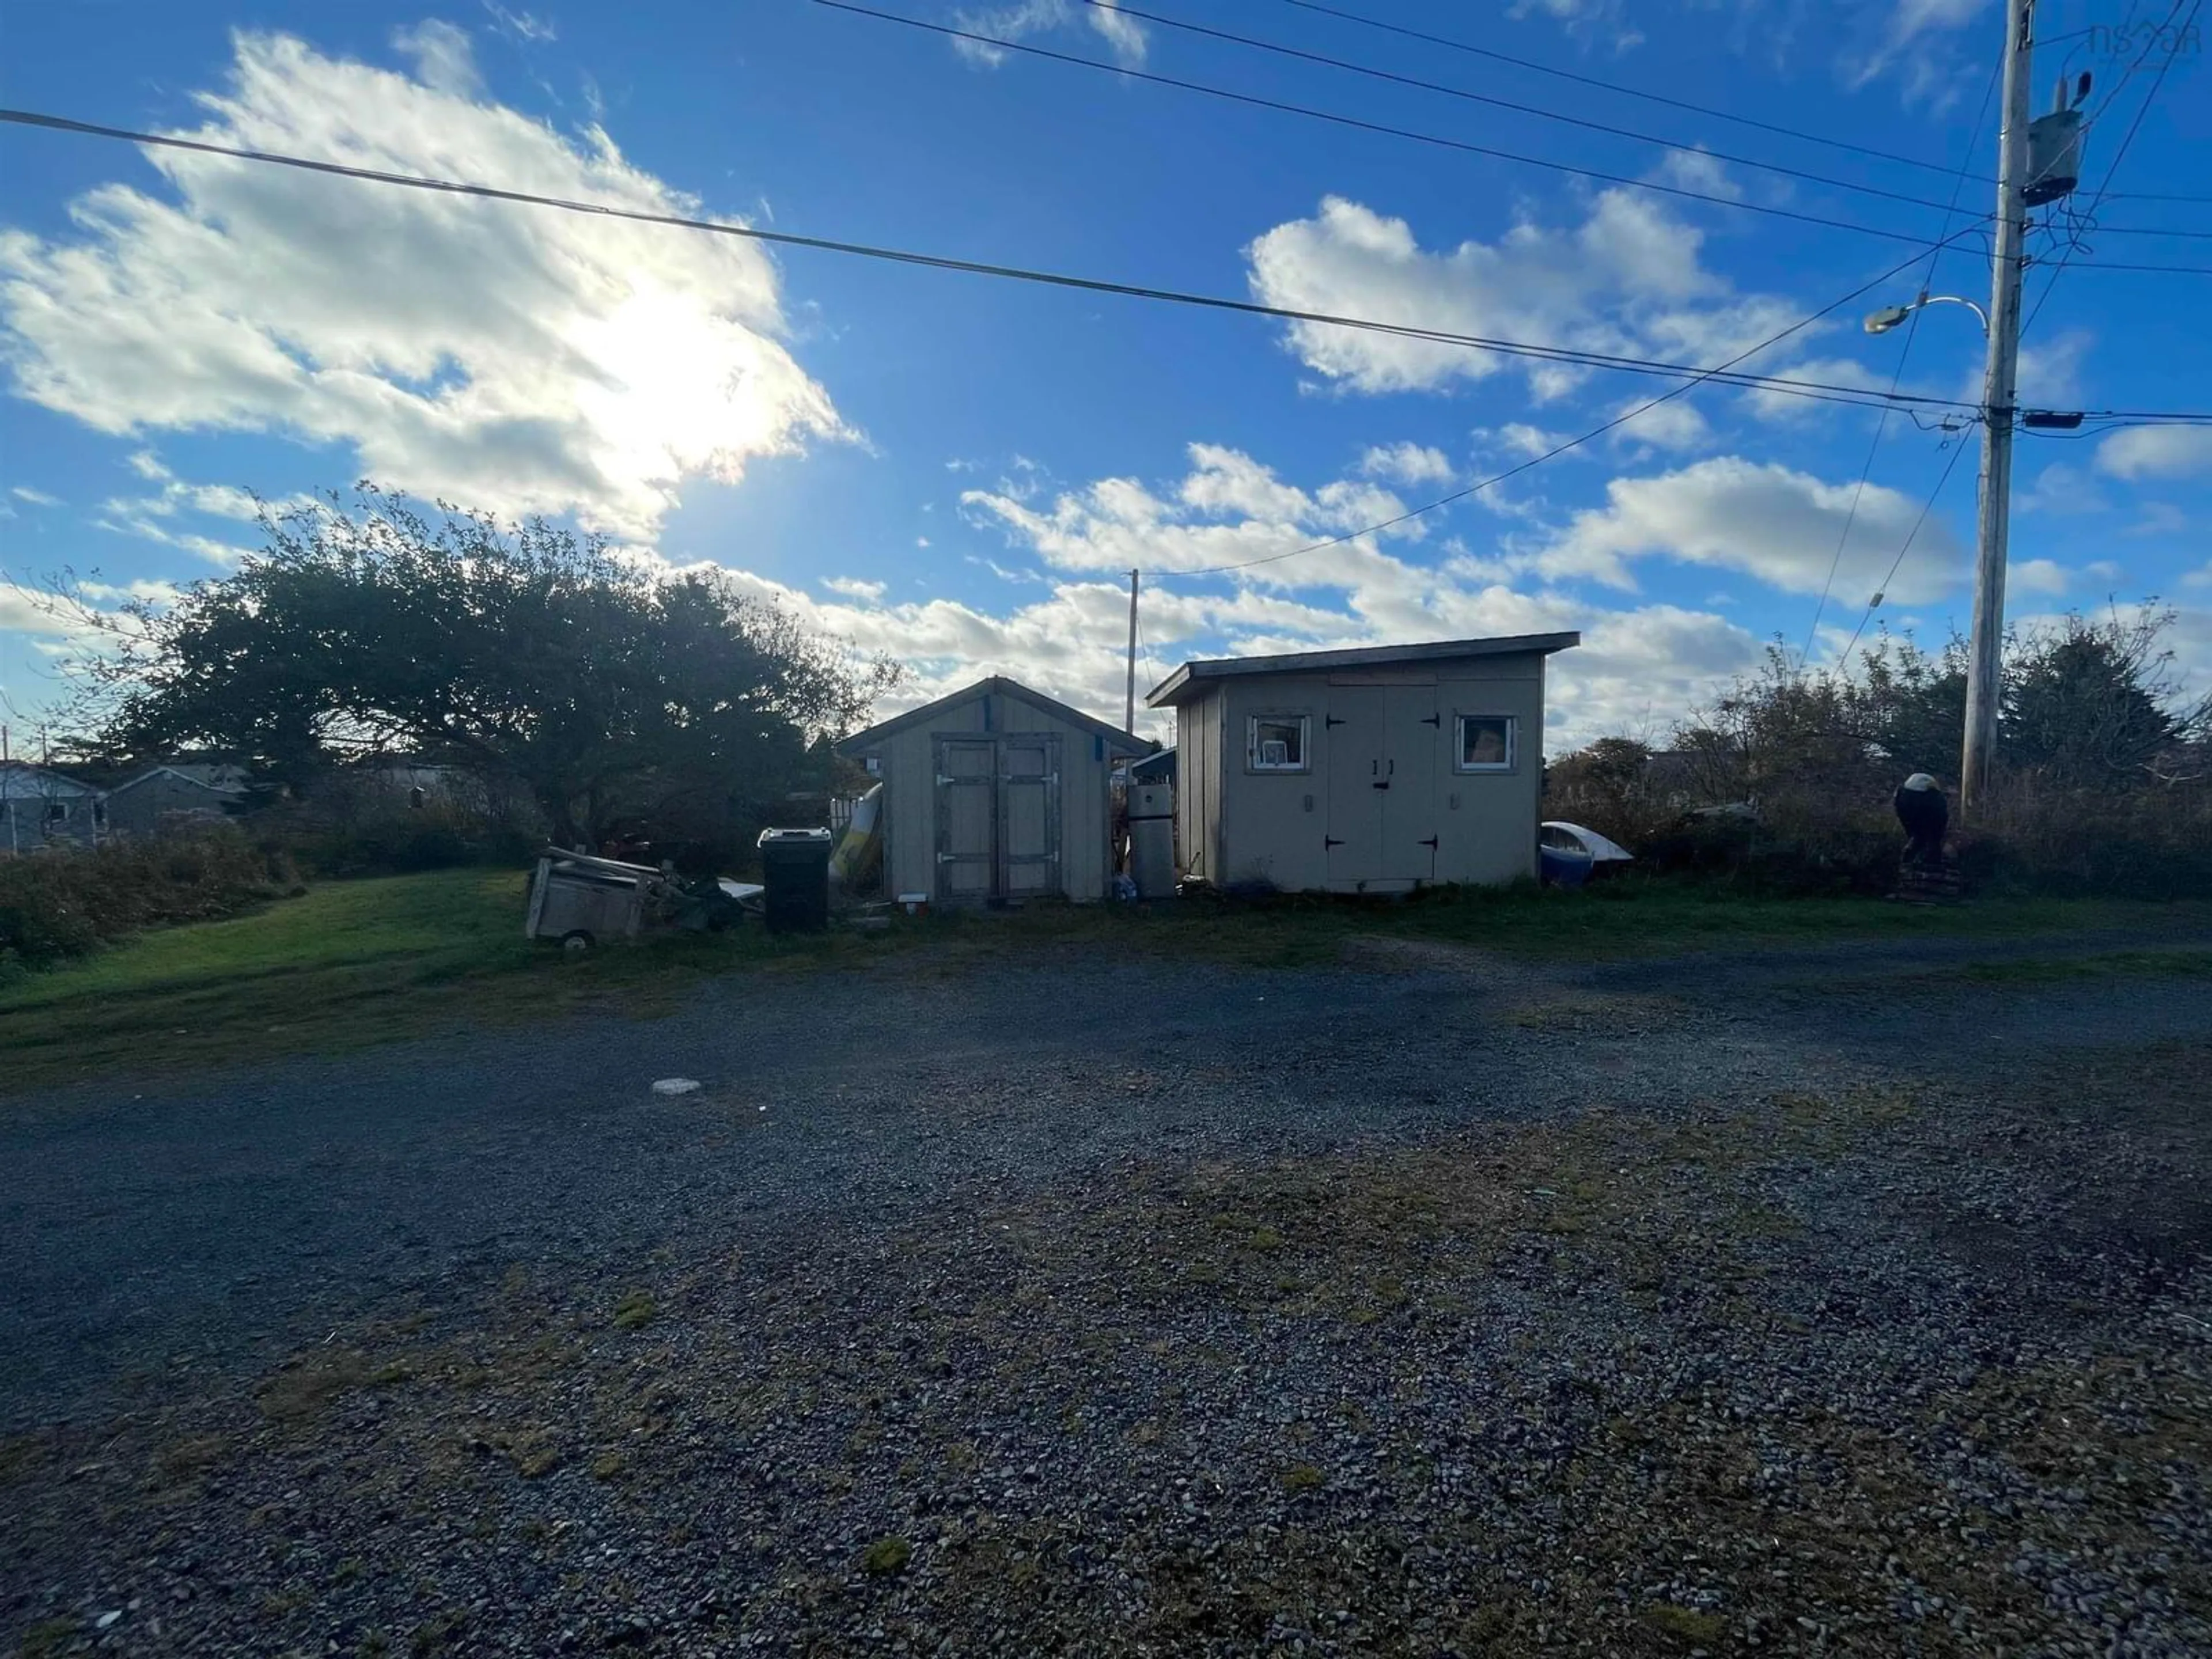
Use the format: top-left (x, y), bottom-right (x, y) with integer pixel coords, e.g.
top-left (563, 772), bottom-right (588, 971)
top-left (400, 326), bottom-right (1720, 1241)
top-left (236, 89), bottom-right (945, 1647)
top-left (0, 825), bottom-right (298, 974)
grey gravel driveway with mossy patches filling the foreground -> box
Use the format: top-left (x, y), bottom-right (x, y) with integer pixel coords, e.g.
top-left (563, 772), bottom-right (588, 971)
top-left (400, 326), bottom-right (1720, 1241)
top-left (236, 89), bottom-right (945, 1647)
top-left (0, 938), bottom-right (2212, 1654)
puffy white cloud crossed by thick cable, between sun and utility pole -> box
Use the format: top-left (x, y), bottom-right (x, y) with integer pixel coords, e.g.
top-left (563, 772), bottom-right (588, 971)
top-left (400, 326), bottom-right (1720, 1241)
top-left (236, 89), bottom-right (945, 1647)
top-left (1245, 190), bottom-right (1796, 400)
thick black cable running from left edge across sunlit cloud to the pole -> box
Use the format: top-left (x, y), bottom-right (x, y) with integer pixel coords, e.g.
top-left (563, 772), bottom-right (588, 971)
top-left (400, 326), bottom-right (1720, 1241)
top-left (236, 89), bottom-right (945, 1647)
top-left (0, 108), bottom-right (2017, 418)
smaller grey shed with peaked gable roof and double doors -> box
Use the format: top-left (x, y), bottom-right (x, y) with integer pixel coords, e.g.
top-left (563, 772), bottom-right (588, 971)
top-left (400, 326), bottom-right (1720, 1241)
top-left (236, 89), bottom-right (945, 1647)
top-left (836, 675), bottom-right (1154, 905)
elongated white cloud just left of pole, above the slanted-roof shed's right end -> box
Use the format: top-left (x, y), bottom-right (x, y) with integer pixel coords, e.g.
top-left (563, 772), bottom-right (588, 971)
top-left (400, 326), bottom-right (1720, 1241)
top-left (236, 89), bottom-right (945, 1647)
top-left (1528, 456), bottom-right (1964, 600)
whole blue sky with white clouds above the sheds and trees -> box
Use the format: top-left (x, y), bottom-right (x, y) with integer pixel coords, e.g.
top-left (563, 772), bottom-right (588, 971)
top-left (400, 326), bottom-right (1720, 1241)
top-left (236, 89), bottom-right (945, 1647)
top-left (0, 0), bottom-right (2212, 750)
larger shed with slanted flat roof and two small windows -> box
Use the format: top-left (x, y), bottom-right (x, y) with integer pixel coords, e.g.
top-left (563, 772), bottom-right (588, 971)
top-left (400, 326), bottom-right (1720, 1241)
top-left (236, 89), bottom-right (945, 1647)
top-left (1146, 632), bottom-right (1582, 893)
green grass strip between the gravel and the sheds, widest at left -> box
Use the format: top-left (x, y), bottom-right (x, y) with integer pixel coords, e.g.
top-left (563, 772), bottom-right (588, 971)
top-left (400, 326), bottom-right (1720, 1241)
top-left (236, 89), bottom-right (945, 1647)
top-left (0, 869), bottom-right (2212, 1093)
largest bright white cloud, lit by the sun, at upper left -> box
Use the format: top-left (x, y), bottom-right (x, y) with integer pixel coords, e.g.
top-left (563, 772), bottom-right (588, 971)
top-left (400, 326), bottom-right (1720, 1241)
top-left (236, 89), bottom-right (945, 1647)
top-left (0, 33), bottom-right (850, 537)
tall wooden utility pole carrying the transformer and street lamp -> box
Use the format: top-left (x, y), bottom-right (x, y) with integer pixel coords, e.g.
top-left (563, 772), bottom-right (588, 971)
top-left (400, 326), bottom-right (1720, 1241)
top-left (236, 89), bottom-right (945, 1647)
top-left (1957, 0), bottom-right (2035, 819)
